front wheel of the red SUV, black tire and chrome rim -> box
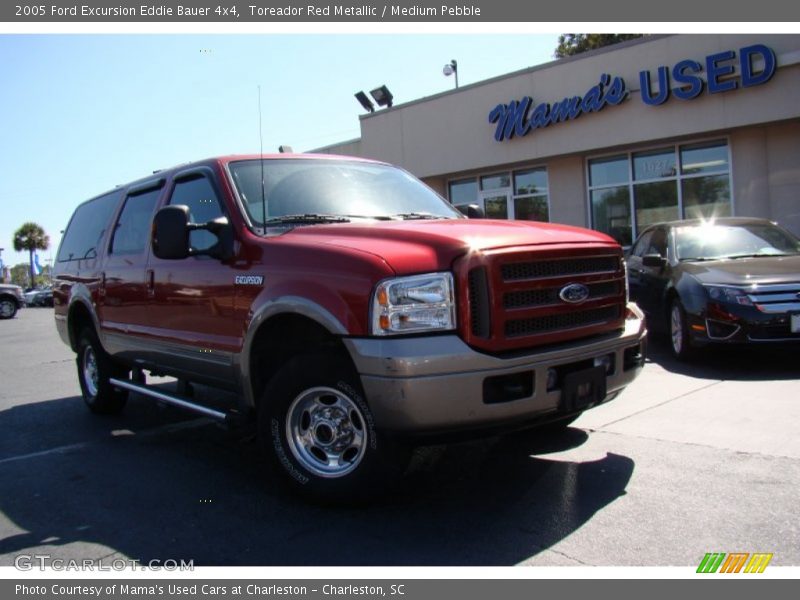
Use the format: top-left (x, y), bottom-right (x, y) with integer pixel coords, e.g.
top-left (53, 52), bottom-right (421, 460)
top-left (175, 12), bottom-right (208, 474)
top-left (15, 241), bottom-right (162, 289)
top-left (258, 353), bottom-right (410, 505)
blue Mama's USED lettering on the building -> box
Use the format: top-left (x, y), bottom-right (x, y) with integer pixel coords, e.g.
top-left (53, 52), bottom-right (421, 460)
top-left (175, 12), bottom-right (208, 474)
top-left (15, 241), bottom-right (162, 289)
top-left (489, 44), bottom-right (777, 142)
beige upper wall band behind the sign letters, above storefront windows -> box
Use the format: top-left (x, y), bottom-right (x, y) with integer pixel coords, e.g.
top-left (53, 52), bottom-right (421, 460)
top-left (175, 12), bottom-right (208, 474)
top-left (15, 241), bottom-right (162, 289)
top-left (361, 34), bottom-right (800, 177)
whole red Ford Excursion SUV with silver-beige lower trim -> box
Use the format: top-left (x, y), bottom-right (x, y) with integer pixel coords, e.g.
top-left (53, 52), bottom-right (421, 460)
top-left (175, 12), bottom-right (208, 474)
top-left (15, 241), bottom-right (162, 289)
top-left (54, 155), bottom-right (645, 501)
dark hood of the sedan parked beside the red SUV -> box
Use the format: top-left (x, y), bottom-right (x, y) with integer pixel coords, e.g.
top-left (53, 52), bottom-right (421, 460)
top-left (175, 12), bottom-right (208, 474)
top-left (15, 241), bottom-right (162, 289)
top-left (680, 255), bottom-right (800, 285)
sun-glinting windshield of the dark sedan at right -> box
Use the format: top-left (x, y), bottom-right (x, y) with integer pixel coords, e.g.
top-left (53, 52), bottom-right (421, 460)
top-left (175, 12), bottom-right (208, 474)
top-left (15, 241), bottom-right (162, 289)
top-left (675, 223), bottom-right (800, 260)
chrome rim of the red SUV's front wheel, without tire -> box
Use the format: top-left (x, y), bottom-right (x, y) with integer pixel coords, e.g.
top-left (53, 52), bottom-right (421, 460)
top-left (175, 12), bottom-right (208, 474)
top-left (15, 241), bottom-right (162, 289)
top-left (286, 387), bottom-right (368, 478)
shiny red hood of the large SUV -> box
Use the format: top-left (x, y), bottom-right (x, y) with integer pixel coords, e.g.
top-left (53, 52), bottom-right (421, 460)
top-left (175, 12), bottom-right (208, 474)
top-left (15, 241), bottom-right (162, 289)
top-left (287, 219), bottom-right (618, 275)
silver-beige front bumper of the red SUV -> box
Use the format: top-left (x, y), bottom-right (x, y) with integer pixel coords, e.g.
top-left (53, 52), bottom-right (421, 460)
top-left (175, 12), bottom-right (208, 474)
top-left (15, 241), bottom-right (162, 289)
top-left (344, 304), bottom-right (647, 434)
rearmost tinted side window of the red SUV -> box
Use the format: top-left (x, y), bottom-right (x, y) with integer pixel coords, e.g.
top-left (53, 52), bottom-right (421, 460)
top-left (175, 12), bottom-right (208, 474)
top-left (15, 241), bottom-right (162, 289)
top-left (56, 192), bottom-right (120, 262)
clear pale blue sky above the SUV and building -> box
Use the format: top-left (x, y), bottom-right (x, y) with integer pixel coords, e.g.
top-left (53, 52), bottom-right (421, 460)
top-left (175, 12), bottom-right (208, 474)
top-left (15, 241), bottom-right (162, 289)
top-left (0, 34), bottom-right (558, 265)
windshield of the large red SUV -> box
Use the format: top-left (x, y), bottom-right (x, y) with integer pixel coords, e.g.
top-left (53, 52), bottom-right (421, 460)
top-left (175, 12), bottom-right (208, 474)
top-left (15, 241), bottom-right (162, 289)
top-left (230, 159), bottom-right (462, 227)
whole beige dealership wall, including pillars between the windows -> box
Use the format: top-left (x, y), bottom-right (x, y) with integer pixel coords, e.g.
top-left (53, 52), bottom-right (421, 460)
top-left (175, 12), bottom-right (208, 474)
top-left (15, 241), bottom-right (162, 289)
top-left (318, 34), bottom-right (800, 235)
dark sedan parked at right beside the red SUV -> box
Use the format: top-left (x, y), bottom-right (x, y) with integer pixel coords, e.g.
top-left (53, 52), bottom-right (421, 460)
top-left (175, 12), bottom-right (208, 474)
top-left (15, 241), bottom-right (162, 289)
top-left (627, 217), bottom-right (800, 359)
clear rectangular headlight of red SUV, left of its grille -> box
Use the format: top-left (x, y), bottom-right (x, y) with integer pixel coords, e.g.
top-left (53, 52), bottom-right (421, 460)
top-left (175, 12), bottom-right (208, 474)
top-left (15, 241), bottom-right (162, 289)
top-left (372, 273), bottom-right (456, 335)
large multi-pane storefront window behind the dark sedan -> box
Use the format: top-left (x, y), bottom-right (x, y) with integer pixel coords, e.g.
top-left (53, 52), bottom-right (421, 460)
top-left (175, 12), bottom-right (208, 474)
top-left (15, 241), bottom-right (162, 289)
top-left (588, 140), bottom-right (732, 245)
